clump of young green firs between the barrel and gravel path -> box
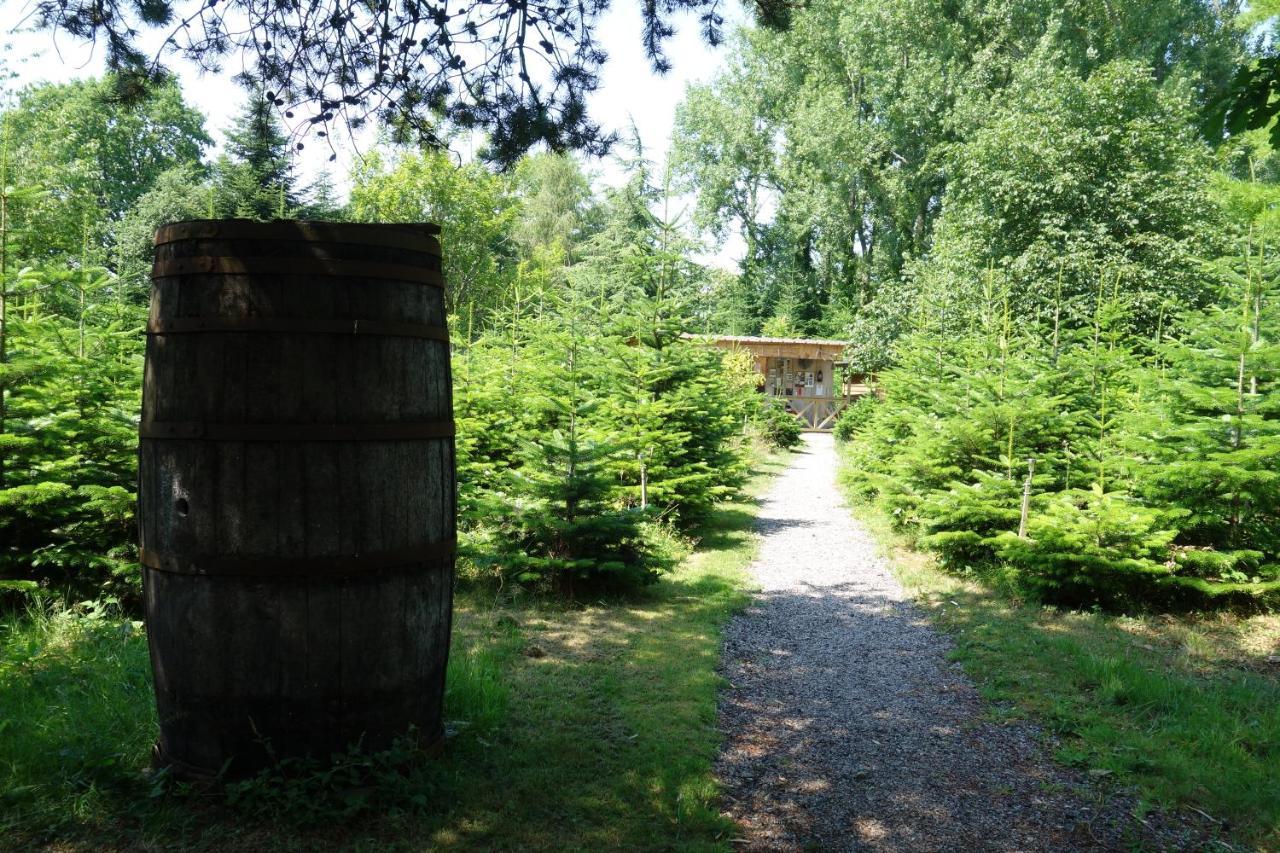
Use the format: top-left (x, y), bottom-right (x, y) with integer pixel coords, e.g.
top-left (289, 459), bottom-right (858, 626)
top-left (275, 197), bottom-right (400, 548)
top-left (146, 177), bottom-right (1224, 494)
top-left (442, 149), bottom-right (756, 589)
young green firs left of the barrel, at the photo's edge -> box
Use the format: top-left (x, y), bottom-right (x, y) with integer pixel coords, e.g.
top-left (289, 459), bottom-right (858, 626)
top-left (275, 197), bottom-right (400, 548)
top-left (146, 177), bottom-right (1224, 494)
top-left (0, 268), bottom-right (143, 598)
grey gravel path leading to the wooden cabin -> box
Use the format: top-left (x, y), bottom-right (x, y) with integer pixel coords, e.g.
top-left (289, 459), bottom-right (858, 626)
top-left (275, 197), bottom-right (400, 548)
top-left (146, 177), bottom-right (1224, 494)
top-left (717, 435), bottom-right (1198, 850)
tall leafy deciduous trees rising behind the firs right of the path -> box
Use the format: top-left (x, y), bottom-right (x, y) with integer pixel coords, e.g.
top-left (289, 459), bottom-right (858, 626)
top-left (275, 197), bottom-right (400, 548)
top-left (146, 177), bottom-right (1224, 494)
top-left (676, 0), bottom-right (1254, 361)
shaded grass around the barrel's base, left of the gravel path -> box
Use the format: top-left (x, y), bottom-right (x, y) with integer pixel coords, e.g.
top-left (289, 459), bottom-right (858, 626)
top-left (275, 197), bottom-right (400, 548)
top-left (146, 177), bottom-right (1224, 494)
top-left (0, 448), bottom-right (785, 850)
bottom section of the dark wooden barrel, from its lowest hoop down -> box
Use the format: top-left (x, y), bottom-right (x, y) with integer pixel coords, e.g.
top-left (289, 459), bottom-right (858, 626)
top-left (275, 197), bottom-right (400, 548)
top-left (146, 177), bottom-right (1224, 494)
top-left (143, 561), bottom-right (452, 777)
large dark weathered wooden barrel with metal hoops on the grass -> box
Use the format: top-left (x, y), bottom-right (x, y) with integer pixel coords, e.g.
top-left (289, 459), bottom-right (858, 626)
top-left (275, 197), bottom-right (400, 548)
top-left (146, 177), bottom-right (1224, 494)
top-left (138, 220), bottom-right (456, 775)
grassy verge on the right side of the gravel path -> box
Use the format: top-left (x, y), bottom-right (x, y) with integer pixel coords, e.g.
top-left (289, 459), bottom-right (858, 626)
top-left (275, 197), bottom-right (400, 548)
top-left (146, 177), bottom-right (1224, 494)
top-left (839, 466), bottom-right (1280, 849)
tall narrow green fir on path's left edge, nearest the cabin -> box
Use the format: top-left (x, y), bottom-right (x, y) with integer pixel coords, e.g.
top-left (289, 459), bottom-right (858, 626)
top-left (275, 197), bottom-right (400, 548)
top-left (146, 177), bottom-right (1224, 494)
top-left (586, 155), bottom-right (748, 525)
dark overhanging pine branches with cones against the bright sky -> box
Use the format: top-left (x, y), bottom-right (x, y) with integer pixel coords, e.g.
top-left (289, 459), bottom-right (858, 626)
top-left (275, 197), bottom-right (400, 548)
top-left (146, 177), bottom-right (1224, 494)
top-left (22, 0), bottom-right (790, 165)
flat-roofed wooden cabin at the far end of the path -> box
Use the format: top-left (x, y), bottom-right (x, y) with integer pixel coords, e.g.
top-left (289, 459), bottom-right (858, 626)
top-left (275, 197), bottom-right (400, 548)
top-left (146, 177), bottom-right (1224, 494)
top-left (690, 334), bottom-right (870, 433)
